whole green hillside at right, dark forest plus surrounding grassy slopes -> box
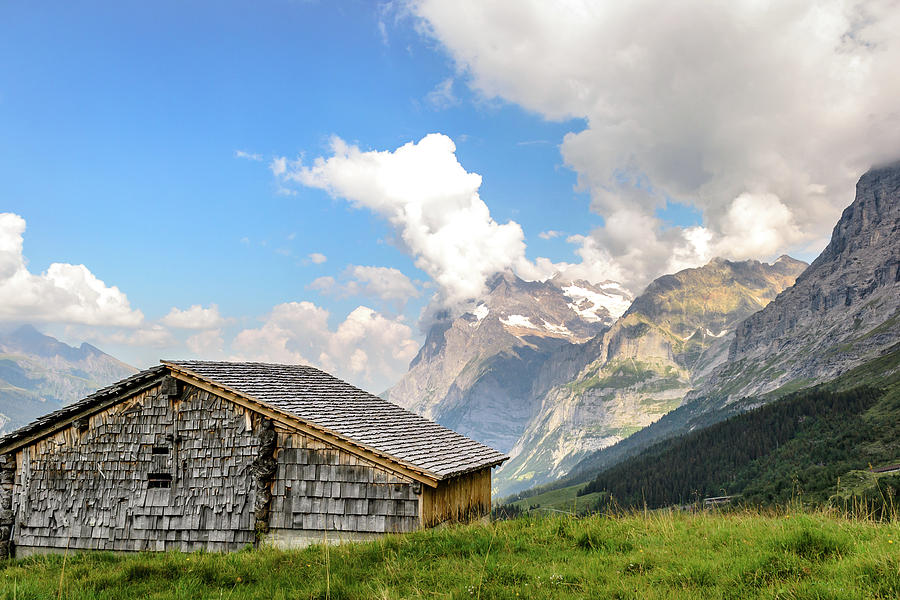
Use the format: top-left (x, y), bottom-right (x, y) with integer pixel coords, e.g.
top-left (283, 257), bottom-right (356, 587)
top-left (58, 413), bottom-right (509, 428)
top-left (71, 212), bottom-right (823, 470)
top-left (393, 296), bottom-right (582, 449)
top-left (502, 347), bottom-right (900, 511)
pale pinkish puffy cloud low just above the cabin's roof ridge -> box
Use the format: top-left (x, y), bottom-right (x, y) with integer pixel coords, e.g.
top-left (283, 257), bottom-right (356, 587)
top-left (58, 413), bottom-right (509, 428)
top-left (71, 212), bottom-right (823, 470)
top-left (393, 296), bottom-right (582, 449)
top-left (231, 302), bottom-right (419, 393)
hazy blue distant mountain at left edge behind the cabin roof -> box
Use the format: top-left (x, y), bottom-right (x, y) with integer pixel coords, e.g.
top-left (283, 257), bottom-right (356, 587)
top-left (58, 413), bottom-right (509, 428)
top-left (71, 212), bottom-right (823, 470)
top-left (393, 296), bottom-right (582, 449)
top-left (0, 325), bottom-right (137, 433)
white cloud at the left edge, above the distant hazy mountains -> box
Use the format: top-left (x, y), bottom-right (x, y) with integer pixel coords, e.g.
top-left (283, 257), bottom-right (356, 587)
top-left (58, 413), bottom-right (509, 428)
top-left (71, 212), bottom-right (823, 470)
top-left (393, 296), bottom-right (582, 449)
top-left (0, 213), bottom-right (144, 327)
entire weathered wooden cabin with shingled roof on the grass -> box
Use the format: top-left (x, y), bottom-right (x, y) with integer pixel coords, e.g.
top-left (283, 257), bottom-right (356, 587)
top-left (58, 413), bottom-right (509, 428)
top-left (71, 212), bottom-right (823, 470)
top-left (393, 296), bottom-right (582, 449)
top-left (0, 361), bottom-right (507, 556)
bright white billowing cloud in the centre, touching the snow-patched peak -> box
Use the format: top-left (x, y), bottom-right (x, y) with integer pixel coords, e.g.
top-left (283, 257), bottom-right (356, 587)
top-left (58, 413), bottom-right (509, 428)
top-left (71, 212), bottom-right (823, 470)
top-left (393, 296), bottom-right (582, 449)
top-left (271, 134), bottom-right (525, 305)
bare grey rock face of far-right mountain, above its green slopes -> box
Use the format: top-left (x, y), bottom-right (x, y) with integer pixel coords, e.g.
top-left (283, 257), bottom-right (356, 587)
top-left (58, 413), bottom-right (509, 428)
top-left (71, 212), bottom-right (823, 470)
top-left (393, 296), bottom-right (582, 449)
top-left (704, 163), bottom-right (900, 401)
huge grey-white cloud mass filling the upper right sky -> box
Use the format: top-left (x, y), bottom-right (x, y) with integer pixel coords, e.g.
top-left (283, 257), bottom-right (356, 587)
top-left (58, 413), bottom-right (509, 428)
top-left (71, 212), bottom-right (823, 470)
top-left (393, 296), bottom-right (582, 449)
top-left (410, 0), bottom-right (900, 287)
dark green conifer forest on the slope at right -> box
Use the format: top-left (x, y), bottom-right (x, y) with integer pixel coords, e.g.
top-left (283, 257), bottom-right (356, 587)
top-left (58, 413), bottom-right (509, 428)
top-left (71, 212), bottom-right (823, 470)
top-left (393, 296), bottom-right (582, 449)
top-left (579, 387), bottom-right (898, 508)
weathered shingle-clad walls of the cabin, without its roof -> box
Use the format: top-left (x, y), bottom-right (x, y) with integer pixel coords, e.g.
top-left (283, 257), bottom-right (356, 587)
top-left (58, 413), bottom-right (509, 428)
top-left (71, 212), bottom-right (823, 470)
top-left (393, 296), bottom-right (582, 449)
top-left (0, 378), bottom-right (491, 554)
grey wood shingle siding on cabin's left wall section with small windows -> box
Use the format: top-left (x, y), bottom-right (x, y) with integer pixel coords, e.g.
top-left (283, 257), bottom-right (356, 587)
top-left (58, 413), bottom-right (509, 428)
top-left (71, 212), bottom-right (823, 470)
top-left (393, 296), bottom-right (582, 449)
top-left (13, 386), bottom-right (259, 552)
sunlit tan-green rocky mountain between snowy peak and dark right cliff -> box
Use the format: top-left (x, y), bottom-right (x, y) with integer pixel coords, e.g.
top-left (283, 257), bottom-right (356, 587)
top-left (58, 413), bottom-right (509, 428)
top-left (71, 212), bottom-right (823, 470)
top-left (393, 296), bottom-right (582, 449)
top-left (495, 256), bottom-right (806, 495)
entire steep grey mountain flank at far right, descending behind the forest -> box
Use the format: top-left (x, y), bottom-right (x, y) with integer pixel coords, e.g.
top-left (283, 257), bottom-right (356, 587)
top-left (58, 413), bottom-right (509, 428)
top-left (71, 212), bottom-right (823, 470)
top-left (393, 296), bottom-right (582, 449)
top-left (512, 162), bottom-right (900, 506)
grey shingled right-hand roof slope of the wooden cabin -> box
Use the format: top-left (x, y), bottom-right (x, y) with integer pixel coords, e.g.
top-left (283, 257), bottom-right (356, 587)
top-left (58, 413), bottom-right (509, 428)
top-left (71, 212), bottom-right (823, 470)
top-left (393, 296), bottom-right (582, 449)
top-left (162, 361), bottom-right (508, 479)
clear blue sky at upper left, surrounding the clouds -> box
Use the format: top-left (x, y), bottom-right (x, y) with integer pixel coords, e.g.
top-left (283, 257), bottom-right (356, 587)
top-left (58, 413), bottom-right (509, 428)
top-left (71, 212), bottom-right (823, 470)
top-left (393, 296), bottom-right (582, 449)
top-left (0, 2), bottom-right (599, 316)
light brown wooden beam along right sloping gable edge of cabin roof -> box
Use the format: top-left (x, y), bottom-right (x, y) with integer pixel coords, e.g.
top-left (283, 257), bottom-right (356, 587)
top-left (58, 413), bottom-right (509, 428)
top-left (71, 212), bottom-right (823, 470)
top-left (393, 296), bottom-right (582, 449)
top-left (166, 370), bottom-right (439, 488)
